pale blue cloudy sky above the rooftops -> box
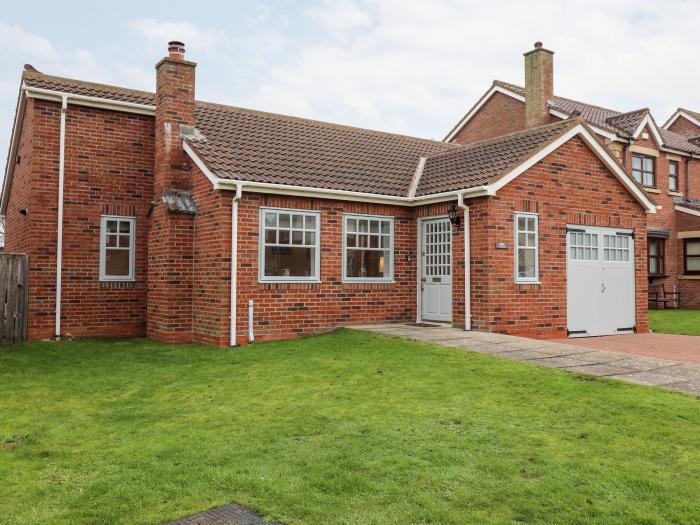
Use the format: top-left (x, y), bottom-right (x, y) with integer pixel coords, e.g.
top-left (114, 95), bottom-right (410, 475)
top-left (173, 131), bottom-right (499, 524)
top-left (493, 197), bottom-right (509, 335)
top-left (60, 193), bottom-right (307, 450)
top-left (0, 0), bottom-right (700, 178)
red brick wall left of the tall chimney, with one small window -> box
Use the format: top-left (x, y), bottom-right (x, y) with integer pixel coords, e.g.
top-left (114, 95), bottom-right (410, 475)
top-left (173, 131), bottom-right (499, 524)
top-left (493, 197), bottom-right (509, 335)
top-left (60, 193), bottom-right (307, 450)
top-left (8, 99), bottom-right (153, 339)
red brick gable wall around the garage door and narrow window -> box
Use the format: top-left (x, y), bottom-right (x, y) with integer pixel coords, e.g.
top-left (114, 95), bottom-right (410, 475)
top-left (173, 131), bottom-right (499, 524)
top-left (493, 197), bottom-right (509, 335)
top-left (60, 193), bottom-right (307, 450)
top-left (472, 138), bottom-right (648, 337)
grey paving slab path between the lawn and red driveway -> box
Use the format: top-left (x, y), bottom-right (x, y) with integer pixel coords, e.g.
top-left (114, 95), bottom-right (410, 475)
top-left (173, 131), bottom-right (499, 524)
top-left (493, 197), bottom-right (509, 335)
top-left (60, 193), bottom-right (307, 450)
top-left (353, 324), bottom-right (700, 396)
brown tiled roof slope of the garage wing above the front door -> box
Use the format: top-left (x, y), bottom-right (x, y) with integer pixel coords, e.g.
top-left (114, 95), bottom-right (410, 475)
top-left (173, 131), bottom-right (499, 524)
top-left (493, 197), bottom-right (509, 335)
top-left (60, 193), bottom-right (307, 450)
top-left (416, 119), bottom-right (580, 196)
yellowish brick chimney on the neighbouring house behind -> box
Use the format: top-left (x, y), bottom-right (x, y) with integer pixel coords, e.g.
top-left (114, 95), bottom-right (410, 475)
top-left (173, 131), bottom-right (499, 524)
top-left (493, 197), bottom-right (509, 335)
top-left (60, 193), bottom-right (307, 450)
top-left (525, 42), bottom-right (554, 128)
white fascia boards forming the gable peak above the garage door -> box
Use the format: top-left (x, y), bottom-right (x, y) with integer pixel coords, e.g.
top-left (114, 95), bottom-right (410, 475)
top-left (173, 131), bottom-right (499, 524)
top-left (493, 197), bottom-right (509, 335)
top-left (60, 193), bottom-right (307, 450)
top-left (490, 124), bottom-right (656, 213)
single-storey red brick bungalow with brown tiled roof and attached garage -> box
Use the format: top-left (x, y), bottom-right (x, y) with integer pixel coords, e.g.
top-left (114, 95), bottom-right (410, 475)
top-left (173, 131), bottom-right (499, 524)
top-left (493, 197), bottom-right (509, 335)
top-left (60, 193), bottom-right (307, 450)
top-left (0, 42), bottom-right (656, 345)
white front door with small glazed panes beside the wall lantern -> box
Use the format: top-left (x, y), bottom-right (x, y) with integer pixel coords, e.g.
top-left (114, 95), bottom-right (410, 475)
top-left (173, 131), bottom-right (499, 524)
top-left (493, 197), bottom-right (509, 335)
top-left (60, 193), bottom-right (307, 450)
top-left (420, 218), bottom-right (452, 321)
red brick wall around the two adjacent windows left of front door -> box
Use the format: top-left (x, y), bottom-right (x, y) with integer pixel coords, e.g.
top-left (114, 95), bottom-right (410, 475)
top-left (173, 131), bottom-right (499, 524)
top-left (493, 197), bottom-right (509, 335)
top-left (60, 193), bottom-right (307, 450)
top-left (227, 193), bottom-right (416, 341)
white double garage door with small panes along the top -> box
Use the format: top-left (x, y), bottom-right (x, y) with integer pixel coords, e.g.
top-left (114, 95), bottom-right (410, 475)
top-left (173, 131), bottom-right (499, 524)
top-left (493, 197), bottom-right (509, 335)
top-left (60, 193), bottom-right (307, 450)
top-left (566, 226), bottom-right (635, 337)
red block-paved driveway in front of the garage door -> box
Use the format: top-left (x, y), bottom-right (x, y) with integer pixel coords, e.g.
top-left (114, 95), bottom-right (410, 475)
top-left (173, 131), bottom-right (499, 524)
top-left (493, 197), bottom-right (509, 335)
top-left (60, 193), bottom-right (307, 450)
top-left (567, 334), bottom-right (700, 365)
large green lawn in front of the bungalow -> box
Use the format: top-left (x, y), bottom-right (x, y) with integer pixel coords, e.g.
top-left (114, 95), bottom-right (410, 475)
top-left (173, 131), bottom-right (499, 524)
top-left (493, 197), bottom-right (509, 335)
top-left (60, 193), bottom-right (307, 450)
top-left (0, 330), bottom-right (700, 525)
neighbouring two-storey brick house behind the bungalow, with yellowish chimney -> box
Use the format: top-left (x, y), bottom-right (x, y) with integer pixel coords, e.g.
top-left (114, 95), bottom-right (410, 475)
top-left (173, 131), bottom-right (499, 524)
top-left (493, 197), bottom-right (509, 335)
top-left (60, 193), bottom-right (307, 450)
top-left (445, 44), bottom-right (700, 307)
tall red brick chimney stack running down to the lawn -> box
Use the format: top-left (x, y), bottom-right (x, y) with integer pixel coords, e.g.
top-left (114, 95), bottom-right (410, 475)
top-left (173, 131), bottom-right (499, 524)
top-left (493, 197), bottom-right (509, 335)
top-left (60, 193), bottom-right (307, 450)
top-left (146, 42), bottom-right (196, 343)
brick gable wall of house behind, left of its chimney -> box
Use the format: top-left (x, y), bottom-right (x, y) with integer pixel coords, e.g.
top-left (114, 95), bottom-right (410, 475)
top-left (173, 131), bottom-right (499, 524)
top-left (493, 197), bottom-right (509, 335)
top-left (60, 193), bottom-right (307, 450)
top-left (452, 92), bottom-right (559, 144)
